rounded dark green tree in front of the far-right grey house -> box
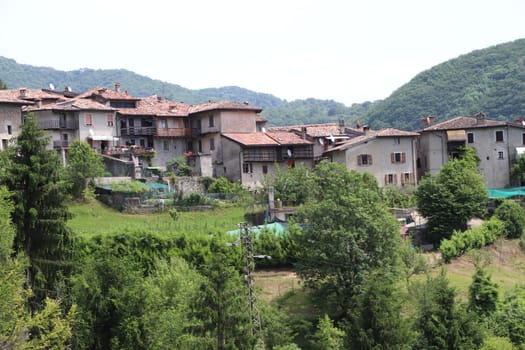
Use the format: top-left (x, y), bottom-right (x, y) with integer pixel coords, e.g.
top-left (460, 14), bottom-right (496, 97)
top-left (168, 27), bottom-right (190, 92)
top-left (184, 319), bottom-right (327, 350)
top-left (415, 147), bottom-right (488, 243)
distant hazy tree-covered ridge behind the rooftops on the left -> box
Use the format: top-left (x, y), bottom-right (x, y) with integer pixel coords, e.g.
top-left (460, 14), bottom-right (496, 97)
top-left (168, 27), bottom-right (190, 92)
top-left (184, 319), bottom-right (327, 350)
top-left (0, 56), bottom-right (369, 125)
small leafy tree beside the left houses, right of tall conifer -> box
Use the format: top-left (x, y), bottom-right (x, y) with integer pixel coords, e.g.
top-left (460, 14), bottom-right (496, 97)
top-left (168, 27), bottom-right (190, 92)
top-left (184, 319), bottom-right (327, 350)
top-left (66, 140), bottom-right (105, 198)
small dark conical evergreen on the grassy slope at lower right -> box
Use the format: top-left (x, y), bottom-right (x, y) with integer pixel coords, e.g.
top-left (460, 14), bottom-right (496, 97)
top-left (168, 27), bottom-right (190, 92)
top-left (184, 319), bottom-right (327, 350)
top-left (469, 267), bottom-right (498, 316)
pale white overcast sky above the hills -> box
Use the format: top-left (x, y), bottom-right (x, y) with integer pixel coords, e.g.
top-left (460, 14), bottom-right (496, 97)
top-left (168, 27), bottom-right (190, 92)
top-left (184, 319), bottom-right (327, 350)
top-left (0, 0), bottom-right (525, 106)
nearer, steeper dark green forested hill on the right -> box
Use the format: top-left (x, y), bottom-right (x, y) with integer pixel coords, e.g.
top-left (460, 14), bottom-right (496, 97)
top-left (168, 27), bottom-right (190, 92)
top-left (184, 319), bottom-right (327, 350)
top-left (366, 39), bottom-right (525, 130)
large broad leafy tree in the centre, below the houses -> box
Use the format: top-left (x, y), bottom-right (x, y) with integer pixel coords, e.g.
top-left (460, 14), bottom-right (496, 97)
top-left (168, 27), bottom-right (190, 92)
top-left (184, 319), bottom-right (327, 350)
top-left (294, 161), bottom-right (401, 318)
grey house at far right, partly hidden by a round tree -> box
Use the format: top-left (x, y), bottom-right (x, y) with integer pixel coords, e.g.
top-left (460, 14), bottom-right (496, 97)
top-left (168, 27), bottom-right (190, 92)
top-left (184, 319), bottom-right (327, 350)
top-left (418, 113), bottom-right (525, 188)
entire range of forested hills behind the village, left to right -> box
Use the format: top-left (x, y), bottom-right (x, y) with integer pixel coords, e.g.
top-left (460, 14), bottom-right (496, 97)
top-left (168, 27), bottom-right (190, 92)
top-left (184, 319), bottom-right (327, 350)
top-left (0, 39), bottom-right (525, 130)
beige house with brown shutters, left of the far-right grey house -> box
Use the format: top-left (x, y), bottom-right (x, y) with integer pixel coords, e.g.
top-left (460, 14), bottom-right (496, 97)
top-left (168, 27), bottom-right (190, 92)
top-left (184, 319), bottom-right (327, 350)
top-left (325, 127), bottom-right (419, 187)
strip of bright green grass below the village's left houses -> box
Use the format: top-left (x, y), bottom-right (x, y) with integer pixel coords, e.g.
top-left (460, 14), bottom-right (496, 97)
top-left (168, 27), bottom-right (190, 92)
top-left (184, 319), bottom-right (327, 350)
top-left (68, 202), bottom-right (244, 236)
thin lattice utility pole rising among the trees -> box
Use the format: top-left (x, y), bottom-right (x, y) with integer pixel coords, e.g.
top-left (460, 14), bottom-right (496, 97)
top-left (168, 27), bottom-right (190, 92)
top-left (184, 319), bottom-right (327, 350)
top-left (239, 222), bottom-right (264, 349)
